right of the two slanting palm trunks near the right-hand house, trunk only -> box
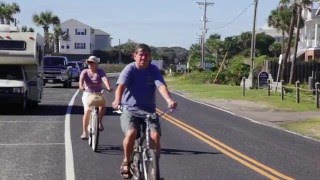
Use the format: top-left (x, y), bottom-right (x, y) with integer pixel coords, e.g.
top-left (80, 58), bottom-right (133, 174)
top-left (289, 5), bottom-right (301, 84)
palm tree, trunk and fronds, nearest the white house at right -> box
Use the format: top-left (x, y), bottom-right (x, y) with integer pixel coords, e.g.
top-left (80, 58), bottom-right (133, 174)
top-left (289, 0), bottom-right (312, 84)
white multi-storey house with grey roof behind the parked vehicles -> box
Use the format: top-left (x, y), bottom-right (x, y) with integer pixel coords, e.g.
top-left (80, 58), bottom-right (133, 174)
top-left (59, 19), bottom-right (111, 59)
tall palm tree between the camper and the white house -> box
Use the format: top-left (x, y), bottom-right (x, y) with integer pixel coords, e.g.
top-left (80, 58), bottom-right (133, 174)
top-left (32, 11), bottom-right (60, 54)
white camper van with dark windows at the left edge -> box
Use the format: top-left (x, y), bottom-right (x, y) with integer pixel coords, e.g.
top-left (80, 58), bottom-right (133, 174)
top-left (0, 25), bottom-right (44, 112)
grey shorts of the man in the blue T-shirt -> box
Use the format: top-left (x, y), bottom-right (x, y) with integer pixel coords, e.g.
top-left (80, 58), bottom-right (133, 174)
top-left (120, 109), bottom-right (161, 135)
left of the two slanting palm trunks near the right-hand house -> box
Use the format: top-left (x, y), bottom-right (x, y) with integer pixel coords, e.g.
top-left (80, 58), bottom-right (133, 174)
top-left (280, 6), bottom-right (296, 80)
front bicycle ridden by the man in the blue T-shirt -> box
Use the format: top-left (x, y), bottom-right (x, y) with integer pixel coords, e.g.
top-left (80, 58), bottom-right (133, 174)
top-left (114, 107), bottom-right (173, 180)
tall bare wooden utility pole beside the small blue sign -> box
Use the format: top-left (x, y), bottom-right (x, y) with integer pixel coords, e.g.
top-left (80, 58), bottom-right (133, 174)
top-left (248, 0), bottom-right (258, 88)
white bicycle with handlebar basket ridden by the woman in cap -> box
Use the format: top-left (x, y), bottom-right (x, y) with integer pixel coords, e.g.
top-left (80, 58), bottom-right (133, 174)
top-left (88, 89), bottom-right (110, 152)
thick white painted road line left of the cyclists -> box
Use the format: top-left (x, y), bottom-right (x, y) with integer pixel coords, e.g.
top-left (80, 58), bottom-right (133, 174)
top-left (64, 90), bottom-right (79, 180)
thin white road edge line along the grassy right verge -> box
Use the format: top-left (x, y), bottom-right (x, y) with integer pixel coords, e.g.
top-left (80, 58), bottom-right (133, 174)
top-left (172, 92), bottom-right (320, 142)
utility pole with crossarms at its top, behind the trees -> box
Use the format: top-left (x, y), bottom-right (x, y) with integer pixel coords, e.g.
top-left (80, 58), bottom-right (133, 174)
top-left (197, 0), bottom-right (214, 69)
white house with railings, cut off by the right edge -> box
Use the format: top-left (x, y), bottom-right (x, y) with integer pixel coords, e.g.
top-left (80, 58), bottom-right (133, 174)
top-left (298, 3), bottom-right (320, 60)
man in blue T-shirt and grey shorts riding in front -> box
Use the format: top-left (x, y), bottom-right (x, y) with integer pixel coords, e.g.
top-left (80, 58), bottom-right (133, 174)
top-left (112, 44), bottom-right (177, 179)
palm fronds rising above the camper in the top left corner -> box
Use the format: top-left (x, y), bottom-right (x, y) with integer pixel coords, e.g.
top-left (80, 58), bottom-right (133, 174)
top-left (0, 2), bottom-right (20, 24)
